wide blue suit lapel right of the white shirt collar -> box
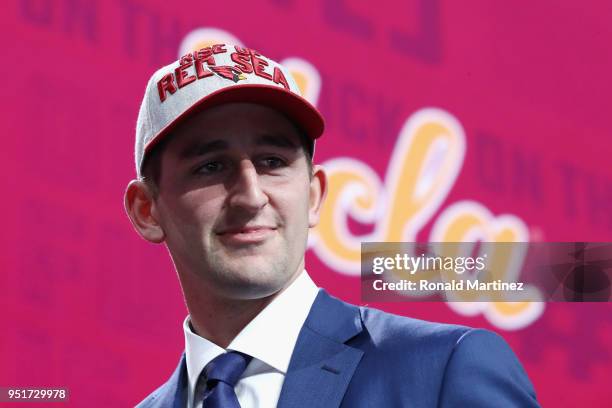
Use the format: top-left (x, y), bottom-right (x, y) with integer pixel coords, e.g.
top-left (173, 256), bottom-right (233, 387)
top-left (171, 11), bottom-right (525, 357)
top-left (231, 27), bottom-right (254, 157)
top-left (278, 290), bottom-right (363, 408)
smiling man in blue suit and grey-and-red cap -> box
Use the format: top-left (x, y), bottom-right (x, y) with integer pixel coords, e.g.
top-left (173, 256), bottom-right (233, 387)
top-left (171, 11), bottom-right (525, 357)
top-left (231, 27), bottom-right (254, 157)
top-left (125, 45), bottom-right (537, 408)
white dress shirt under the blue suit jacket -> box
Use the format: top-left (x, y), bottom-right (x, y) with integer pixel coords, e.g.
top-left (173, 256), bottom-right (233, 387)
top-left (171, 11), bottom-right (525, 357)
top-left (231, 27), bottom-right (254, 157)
top-left (183, 271), bottom-right (318, 408)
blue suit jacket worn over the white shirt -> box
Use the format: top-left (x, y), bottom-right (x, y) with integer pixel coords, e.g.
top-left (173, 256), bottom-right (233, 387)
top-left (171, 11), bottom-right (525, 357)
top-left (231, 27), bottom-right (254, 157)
top-left (139, 290), bottom-right (539, 408)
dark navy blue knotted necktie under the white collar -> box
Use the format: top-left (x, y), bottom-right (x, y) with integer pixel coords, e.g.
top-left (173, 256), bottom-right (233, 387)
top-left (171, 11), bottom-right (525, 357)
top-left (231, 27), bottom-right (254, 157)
top-left (202, 351), bottom-right (252, 408)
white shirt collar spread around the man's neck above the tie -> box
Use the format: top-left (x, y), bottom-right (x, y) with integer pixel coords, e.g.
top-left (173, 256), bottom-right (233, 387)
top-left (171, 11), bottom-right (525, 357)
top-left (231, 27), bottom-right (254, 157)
top-left (183, 271), bottom-right (318, 390)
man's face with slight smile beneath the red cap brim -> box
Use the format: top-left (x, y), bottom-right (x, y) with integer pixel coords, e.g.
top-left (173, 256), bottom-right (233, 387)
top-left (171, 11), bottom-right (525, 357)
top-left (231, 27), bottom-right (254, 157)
top-left (151, 103), bottom-right (324, 299)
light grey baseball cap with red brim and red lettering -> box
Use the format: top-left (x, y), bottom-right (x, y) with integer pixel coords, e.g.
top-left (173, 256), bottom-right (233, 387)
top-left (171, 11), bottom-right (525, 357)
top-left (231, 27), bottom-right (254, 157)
top-left (135, 44), bottom-right (325, 178)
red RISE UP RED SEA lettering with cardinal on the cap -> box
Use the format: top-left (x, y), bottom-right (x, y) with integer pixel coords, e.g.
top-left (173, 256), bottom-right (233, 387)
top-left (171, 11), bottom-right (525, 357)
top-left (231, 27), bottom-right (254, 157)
top-left (157, 44), bottom-right (290, 102)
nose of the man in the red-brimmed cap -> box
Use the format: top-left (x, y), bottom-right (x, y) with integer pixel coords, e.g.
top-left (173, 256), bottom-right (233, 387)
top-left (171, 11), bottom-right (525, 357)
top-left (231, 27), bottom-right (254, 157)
top-left (229, 160), bottom-right (268, 212)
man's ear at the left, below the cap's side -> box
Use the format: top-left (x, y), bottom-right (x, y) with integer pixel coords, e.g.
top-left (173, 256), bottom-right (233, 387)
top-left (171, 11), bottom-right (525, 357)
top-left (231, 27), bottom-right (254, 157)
top-left (124, 180), bottom-right (166, 244)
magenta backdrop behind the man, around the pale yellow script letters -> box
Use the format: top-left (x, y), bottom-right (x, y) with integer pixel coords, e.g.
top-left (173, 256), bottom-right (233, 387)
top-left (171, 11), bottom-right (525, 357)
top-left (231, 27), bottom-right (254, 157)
top-left (0, 0), bottom-right (612, 407)
